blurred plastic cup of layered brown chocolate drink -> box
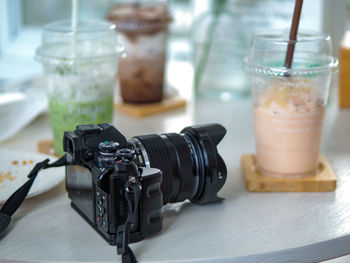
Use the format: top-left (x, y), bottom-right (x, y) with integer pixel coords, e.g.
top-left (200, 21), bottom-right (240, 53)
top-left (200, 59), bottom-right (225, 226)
top-left (106, 1), bottom-right (171, 103)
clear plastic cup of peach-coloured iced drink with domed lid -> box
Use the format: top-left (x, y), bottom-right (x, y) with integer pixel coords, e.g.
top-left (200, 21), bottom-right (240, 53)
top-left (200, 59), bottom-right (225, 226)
top-left (244, 31), bottom-right (338, 178)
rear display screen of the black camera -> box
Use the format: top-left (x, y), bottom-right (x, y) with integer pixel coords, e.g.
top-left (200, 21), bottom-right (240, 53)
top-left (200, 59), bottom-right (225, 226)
top-left (66, 165), bottom-right (94, 221)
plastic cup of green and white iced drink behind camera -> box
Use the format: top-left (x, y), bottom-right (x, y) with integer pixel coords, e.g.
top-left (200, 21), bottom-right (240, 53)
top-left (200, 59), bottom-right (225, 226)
top-left (36, 21), bottom-right (121, 155)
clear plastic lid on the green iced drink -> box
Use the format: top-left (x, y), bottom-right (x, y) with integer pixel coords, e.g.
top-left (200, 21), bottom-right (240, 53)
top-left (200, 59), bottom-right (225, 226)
top-left (35, 20), bottom-right (123, 63)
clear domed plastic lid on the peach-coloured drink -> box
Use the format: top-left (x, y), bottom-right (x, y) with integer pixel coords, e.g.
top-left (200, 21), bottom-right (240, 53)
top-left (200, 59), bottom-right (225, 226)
top-left (244, 30), bottom-right (338, 76)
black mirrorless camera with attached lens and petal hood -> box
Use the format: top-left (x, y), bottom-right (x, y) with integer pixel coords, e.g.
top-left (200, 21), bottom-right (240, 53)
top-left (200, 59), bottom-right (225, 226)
top-left (63, 124), bottom-right (227, 254)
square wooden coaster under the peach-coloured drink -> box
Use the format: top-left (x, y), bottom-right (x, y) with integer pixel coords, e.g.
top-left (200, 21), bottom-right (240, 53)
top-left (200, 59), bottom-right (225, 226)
top-left (241, 154), bottom-right (337, 192)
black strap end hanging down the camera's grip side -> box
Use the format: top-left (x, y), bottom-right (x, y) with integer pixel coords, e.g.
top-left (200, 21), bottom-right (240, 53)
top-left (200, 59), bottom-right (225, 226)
top-left (117, 176), bottom-right (141, 263)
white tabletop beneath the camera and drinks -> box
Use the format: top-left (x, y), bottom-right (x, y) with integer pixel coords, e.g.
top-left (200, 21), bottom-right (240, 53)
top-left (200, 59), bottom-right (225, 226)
top-left (0, 94), bottom-right (350, 262)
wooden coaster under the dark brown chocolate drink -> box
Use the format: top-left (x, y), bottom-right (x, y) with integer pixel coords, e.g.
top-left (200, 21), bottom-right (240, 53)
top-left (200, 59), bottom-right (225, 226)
top-left (114, 97), bottom-right (186, 118)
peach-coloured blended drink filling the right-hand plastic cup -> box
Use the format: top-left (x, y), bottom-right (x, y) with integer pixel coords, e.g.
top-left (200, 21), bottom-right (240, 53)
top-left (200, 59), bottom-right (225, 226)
top-left (253, 78), bottom-right (326, 177)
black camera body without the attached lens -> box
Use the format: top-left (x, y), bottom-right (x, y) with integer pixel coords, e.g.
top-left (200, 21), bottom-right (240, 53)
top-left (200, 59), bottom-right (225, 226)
top-left (63, 124), bottom-right (163, 245)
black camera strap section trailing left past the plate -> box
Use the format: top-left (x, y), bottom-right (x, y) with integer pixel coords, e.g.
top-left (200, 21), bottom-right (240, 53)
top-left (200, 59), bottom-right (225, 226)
top-left (0, 155), bottom-right (67, 237)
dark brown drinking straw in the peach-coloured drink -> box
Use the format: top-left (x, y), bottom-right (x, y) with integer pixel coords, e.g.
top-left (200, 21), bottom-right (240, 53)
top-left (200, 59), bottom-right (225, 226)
top-left (284, 0), bottom-right (303, 69)
